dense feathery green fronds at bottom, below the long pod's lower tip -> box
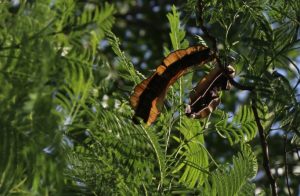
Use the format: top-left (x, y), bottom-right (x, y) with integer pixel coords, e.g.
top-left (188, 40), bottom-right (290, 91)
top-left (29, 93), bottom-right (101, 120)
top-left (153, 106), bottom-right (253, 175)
top-left (66, 105), bottom-right (157, 194)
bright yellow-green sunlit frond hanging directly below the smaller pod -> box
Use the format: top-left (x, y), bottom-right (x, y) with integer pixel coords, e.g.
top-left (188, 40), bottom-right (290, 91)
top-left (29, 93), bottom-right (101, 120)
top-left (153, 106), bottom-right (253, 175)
top-left (173, 117), bottom-right (209, 188)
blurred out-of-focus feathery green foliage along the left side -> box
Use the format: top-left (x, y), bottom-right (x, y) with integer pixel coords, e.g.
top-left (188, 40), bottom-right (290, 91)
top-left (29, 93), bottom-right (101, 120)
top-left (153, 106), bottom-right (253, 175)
top-left (0, 0), bottom-right (114, 195)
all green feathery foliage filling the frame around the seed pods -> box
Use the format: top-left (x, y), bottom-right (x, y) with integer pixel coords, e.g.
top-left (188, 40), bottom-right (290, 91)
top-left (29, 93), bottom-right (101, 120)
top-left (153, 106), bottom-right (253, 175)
top-left (0, 0), bottom-right (300, 196)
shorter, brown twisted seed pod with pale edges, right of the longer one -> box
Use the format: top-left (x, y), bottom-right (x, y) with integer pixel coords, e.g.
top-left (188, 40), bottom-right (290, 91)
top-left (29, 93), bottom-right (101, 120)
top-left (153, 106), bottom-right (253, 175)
top-left (185, 66), bottom-right (235, 118)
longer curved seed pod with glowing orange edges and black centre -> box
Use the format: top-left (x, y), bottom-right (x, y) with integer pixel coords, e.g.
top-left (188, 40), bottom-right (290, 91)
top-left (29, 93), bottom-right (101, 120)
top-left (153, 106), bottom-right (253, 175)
top-left (130, 45), bottom-right (214, 125)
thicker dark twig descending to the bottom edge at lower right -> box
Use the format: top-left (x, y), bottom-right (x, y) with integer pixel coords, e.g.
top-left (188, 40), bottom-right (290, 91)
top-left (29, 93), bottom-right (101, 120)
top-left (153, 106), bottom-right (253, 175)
top-left (251, 99), bottom-right (278, 196)
